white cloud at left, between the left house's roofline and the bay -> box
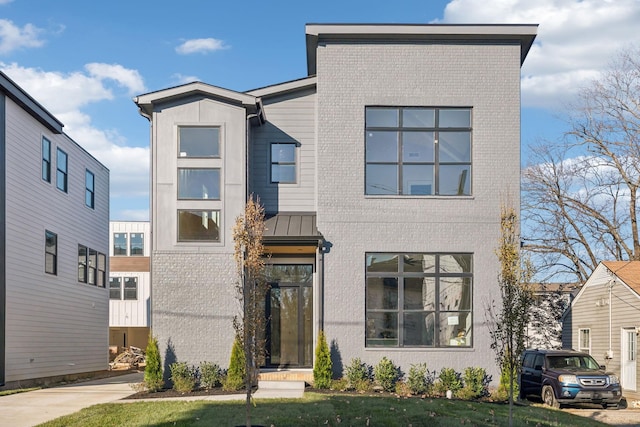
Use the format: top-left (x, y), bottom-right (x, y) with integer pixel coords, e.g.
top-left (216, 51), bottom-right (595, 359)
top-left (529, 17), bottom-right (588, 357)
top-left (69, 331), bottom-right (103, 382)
top-left (0, 63), bottom-right (150, 216)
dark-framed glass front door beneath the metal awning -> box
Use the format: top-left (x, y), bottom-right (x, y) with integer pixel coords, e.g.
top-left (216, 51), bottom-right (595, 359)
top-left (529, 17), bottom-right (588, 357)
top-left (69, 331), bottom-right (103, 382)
top-left (266, 264), bottom-right (313, 367)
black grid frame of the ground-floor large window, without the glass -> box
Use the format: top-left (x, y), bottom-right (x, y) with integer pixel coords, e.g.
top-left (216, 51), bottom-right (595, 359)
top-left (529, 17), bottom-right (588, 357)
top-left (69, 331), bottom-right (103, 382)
top-left (365, 252), bottom-right (475, 349)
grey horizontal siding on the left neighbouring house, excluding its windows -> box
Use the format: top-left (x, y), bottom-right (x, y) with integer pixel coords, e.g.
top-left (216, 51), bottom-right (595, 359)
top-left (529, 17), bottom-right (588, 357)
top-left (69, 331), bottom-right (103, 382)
top-left (5, 99), bottom-right (109, 382)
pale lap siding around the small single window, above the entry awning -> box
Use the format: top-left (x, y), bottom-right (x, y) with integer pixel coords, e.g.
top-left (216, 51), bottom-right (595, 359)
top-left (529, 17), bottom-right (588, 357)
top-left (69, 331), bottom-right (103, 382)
top-left (250, 88), bottom-right (316, 213)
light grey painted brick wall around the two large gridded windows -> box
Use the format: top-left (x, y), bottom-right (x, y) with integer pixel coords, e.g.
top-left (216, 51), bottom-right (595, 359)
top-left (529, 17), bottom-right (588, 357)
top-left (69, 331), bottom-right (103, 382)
top-left (317, 43), bottom-right (520, 378)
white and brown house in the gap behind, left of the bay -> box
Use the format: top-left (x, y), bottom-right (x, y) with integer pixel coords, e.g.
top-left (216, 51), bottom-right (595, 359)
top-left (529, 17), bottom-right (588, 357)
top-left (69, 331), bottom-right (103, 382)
top-left (109, 221), bottom-right (151, 354)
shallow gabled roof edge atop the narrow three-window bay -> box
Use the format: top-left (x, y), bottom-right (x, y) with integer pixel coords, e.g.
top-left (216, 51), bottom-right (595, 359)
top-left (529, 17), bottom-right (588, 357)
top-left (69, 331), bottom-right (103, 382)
top-left (133, 82), bottom-right (266, 123)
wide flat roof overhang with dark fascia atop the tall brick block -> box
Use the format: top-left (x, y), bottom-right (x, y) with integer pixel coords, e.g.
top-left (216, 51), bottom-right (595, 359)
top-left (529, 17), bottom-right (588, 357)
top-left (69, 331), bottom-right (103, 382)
top-left (306, 24), bottom-right (538, 75)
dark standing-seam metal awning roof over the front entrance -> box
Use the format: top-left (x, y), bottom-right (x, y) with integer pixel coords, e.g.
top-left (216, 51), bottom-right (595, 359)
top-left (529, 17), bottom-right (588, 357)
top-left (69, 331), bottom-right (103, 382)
top-left (263, 212), bottom-right (323, 246)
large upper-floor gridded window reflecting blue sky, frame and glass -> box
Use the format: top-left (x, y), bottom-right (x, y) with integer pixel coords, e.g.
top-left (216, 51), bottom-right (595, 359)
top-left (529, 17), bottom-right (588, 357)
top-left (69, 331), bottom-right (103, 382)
top-left (365, 107), bottom-right (471, 196)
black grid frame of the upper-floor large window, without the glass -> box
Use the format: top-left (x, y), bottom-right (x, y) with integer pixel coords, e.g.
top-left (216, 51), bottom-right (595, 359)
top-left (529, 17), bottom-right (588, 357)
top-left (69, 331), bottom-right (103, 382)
top-left (364, 105), bottom-right (473, 197)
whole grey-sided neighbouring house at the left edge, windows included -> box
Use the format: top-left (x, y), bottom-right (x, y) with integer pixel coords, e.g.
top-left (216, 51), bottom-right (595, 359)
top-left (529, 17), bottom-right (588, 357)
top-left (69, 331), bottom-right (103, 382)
top-left (0, 73), bottom-right (109, 384)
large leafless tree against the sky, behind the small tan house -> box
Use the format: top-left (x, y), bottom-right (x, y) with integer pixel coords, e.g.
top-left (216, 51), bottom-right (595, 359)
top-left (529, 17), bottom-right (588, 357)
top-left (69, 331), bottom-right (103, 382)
top-left (522, 48), bottom-right (640, 283)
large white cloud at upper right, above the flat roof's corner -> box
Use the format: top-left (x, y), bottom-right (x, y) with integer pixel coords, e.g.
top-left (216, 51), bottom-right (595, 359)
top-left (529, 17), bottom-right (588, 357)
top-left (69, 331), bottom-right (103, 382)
top-left (442, 0), bottom-right (640, 108)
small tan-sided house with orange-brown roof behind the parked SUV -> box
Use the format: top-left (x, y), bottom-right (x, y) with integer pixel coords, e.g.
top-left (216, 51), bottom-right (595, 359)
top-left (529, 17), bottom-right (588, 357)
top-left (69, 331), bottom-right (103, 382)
top-left (562, 261), bottom-right (640, 401)
